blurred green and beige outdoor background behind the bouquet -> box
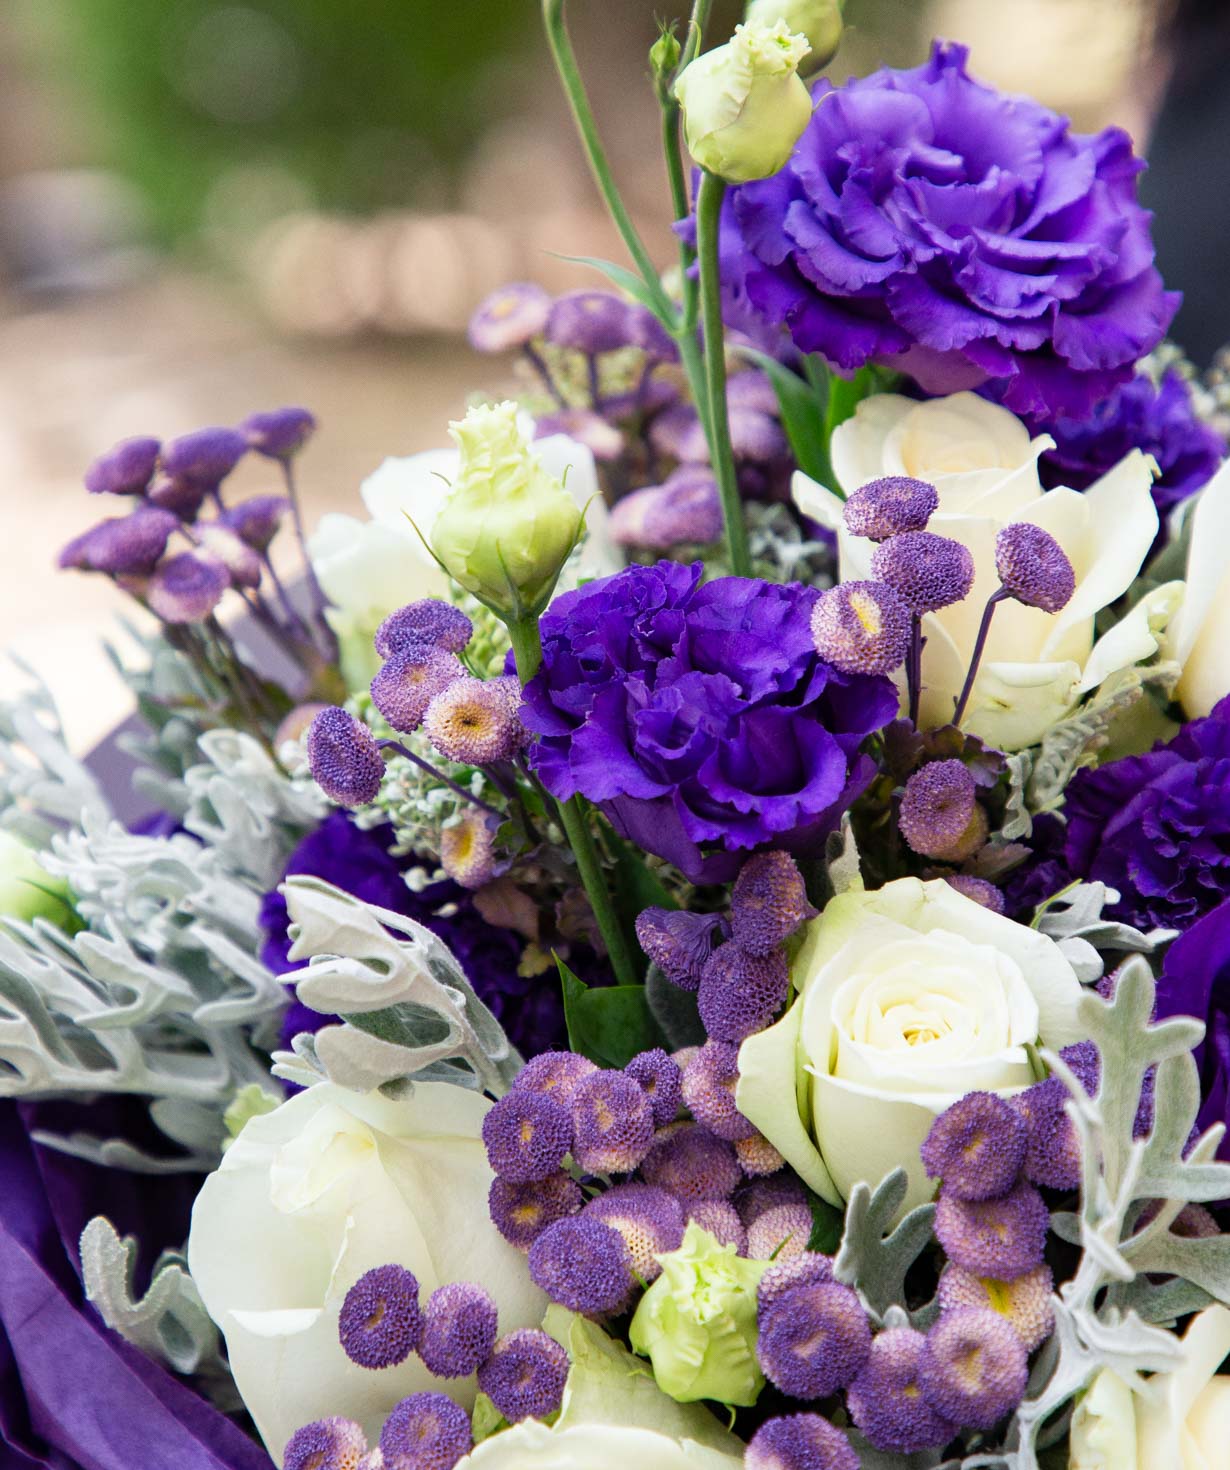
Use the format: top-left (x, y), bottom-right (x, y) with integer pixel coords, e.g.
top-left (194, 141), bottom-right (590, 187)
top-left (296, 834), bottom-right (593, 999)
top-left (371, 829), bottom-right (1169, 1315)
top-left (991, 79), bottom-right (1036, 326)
top-left (0, 0), bottom-right (1210, 745)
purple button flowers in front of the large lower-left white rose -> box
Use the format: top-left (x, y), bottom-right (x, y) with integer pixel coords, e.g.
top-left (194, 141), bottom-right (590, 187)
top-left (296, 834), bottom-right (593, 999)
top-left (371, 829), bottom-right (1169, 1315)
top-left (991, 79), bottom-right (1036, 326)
top-left (284, 1264), bottom-right (569, 1470)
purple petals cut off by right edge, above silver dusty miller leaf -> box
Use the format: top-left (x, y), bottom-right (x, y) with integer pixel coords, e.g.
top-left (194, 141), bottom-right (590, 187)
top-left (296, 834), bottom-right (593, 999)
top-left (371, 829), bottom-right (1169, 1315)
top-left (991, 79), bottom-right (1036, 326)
top-left (1157, 900), bottom-right (1230, 1160)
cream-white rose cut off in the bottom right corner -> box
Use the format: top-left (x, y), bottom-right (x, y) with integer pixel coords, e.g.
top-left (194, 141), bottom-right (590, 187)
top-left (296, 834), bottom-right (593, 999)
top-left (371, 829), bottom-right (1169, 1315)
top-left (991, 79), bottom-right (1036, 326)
top-left (1068, 1305), bottom-right (1230, 1470)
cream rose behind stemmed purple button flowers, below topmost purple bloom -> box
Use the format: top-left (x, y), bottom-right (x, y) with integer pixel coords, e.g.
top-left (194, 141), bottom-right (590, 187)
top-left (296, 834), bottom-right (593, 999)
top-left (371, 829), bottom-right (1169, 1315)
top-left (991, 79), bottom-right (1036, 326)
top-left (795, 392), bottom-right (1158, 750)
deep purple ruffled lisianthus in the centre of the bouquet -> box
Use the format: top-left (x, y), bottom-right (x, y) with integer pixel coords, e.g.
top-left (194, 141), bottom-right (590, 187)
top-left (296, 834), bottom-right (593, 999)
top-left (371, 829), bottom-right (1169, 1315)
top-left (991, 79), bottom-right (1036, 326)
top-left (522, 562), bottom-right (896, 882)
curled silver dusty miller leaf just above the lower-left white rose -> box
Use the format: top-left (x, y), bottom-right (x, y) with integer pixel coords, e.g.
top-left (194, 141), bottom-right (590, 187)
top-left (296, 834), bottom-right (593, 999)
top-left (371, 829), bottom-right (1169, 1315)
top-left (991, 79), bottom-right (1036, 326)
top-left (273, 876), bottom-right (522, 1097)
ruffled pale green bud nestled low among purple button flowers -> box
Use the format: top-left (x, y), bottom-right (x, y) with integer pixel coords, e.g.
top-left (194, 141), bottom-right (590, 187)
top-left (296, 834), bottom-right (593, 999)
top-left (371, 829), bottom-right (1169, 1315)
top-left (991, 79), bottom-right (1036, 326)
top-left (629, 1225), bottom-right (769, 1405)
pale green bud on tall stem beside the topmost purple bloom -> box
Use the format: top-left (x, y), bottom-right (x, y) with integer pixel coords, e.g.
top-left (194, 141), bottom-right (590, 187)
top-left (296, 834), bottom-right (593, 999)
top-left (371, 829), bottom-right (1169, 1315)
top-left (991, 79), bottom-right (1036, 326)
top-left (675, 21), bottom-right (811, 184)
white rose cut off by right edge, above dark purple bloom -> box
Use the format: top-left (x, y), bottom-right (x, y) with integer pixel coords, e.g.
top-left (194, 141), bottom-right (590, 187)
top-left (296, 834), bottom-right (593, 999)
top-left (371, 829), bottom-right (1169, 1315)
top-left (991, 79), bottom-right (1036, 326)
top-left (1171, 460), bottom-right (1230, 719)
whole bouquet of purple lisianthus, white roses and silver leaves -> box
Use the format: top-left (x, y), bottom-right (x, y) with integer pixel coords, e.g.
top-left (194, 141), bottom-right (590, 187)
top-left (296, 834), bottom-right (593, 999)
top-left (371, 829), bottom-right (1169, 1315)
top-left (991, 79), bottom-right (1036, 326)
top-left (0, 0), bottom-right (1230, 1470)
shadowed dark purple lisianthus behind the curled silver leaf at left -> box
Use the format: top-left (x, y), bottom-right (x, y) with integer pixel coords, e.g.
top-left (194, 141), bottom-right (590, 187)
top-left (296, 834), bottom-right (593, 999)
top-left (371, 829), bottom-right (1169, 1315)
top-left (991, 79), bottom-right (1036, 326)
top-left (260, 811), bottom-right (566, 1055)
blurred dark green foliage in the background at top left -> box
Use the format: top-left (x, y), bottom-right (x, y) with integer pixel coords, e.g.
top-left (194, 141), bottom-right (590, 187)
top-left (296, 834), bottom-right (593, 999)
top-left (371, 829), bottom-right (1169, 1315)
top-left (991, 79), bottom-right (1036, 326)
top-left (36, 0), bottom-right (538, 238)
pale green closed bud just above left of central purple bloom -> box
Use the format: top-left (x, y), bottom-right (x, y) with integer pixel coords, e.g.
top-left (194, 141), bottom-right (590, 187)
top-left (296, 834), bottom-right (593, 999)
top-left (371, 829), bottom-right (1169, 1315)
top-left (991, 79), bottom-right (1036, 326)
top-left (431, 403), bottom-right (580, 620)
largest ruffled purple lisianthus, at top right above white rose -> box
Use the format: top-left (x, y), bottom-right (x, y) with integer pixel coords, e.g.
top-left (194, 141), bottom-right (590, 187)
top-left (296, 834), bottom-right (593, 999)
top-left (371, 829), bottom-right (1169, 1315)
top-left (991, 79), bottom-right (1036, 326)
top-left (714, 41), bottom-right (1179, 416)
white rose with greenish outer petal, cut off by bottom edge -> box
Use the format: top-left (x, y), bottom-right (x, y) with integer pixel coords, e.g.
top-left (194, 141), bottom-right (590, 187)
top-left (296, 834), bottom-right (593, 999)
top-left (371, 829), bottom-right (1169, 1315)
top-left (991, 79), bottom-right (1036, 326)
top-left (457, 1307), bottom-right (744, 1470)
